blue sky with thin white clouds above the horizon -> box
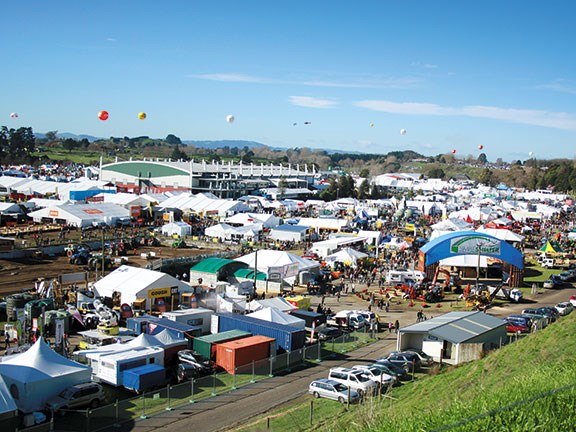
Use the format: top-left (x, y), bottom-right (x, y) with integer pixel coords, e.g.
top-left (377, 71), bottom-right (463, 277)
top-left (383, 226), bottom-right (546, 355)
top-left (0, 0), bottom-right (576, 161)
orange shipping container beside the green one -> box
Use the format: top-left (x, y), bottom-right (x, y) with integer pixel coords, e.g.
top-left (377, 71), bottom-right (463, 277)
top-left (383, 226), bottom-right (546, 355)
top-left (216, 336), bottom-right (276, 374)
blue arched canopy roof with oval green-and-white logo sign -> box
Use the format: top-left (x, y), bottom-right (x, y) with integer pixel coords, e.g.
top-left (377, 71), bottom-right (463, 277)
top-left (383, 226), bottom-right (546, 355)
top-left (420, 231), bottom-right (524, 269)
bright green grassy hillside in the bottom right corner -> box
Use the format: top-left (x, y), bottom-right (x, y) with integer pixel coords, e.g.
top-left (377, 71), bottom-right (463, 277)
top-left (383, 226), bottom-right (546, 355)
top-left (244, 313), bottom-right (576, 432)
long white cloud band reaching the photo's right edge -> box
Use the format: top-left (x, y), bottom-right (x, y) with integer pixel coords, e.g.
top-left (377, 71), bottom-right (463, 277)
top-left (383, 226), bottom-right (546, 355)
top-left (354, 100), bottom-right (576, 130)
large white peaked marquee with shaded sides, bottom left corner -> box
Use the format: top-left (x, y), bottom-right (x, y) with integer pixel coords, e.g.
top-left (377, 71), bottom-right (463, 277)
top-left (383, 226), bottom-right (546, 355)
top-left (0, 338), bottom-right (92, 413)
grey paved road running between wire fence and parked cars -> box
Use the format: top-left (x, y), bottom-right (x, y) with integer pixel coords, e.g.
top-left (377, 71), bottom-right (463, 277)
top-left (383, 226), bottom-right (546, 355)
top-left (106, 287), bottom-right (576, 432)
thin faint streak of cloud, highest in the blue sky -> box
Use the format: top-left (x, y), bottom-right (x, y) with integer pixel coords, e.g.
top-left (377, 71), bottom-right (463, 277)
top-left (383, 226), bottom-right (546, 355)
top-left (187, 73), bottom-right (422, 88)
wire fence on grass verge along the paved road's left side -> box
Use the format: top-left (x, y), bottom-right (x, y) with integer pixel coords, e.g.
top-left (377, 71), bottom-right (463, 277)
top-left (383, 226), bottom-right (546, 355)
top-left (19, 332), bottom-right (376, 432)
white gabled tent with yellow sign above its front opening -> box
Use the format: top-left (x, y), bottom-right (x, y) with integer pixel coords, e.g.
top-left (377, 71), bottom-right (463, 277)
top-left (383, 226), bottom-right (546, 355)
top-left (94, 265), bottom-right (192, 309)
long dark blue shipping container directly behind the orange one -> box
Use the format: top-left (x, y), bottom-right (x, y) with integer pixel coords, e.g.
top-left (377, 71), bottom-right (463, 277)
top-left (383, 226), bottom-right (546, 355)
top-left (215, 314), bottom-right (306, 351)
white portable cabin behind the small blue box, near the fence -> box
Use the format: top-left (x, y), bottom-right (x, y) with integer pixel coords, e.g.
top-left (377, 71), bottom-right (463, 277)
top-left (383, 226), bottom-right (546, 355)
top-left (96, 347), bottom-right (164, 387)
